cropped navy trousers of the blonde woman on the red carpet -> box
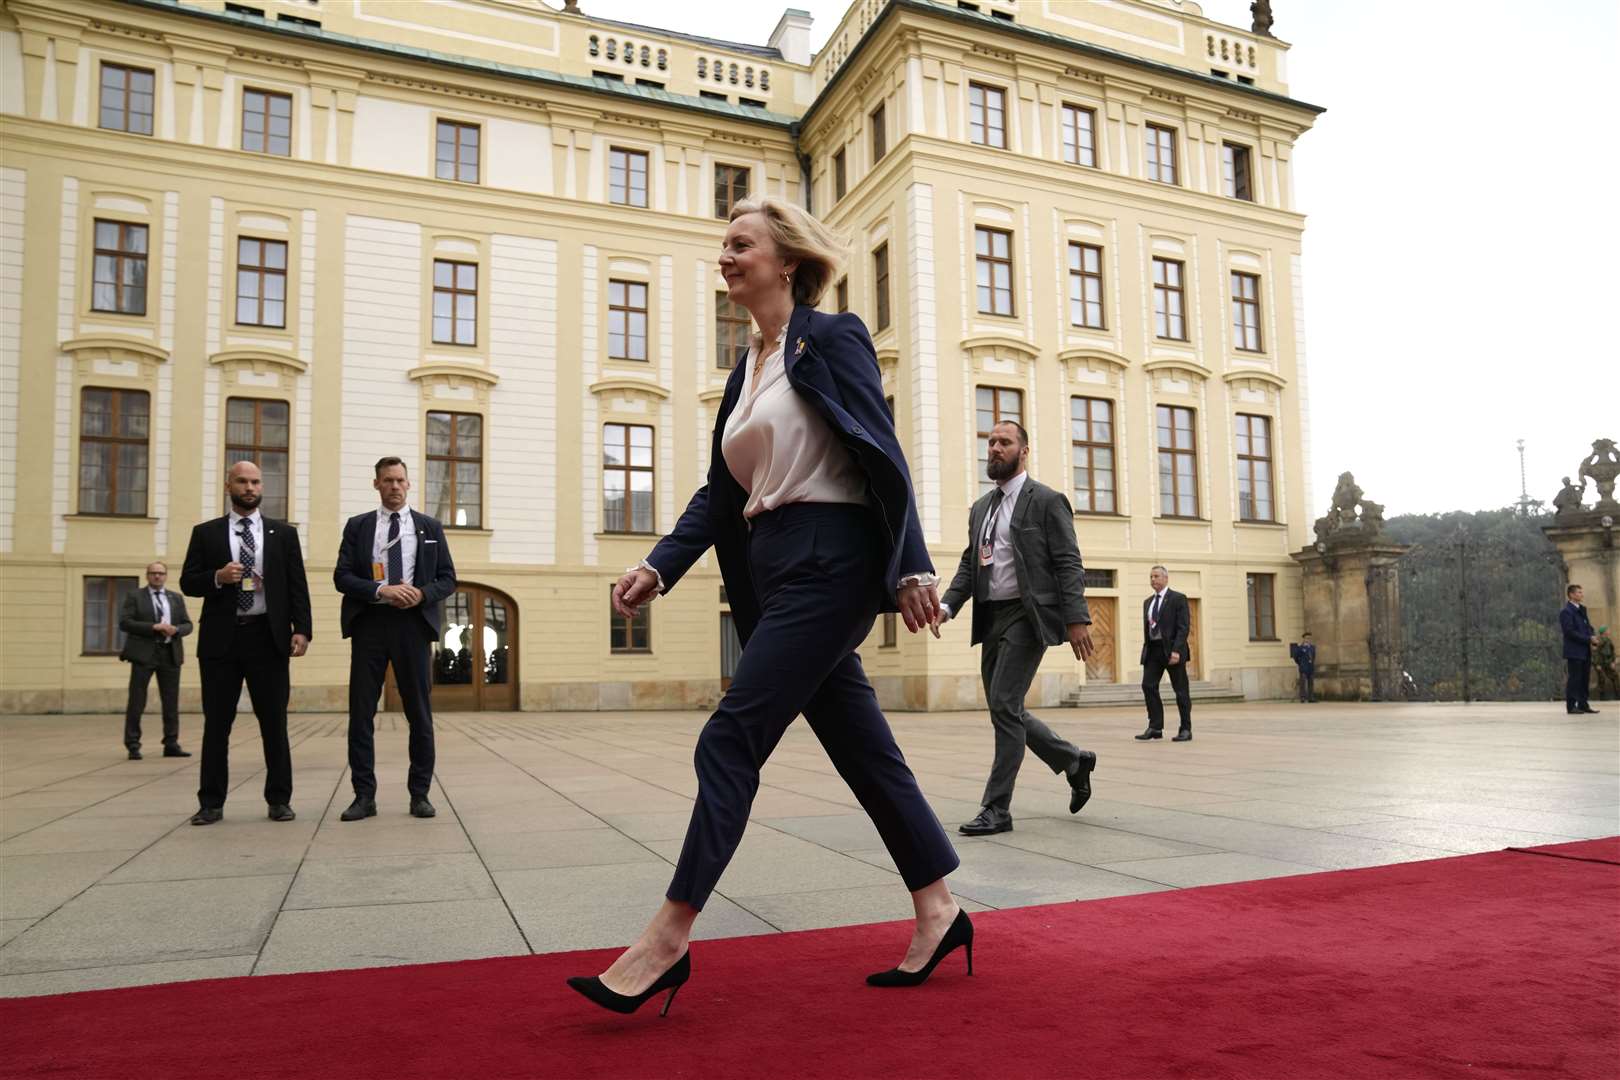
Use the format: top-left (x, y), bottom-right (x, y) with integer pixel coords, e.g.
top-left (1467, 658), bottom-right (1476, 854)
top-left (666, 502), bottom-right (957, 910)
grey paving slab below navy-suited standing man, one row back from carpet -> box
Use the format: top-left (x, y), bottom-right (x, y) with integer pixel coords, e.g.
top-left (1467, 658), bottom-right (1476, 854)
top-left (282, 853), bottom-right (496, 912)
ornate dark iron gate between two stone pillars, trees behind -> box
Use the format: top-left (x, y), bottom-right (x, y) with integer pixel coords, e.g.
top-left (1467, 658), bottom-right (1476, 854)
top-left (1400, 520), bottom-right (1563, 701)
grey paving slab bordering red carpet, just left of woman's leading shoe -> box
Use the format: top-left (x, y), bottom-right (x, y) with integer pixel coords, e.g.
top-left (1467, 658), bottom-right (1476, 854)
top-left (254, 900), bottom-right (530, 975)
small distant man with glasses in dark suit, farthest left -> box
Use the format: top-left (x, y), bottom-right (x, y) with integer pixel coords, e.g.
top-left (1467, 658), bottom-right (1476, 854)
top-left (118, 562), bottom-right (191, 761)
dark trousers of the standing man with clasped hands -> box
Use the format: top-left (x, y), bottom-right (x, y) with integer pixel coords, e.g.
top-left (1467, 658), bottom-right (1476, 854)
top-left (348, 604), bottom-right (434, 798)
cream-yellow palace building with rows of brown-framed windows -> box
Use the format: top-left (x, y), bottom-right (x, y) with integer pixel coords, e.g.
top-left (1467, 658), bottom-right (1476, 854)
top-left (0, 0), bottom-right (1320, 712)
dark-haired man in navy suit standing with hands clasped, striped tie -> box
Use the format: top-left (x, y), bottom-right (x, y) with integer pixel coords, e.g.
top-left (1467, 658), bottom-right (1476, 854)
top-left (332, 457), bottom-right (455, 821)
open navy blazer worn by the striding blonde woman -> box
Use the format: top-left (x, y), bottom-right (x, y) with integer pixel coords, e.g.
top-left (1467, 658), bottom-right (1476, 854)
top-left (646, 304), bottom-right (933, 641)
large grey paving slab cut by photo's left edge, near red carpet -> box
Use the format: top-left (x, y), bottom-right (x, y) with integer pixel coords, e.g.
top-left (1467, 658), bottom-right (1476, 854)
top-left (0, 874), bottom-right (290, 975)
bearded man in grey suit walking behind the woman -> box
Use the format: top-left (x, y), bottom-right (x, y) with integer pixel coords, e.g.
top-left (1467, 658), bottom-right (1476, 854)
top-left (933, 421), bottom-right (1097, 836)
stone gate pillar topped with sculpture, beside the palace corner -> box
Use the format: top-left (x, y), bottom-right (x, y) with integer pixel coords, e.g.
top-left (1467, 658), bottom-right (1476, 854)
top-left (1293, 473), bottom-right (1406, 701)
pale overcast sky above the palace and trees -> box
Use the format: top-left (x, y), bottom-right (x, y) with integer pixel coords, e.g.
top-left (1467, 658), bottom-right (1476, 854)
top-left (580, 0), bottom-right (1620, 517)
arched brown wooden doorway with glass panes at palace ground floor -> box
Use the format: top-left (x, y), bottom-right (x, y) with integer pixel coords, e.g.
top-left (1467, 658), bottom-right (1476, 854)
top-left (384, 583), bottom-right (518, 711)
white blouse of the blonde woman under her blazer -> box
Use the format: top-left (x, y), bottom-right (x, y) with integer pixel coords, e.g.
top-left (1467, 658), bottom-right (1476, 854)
top-left (719, 329), bottom-right (867, 518)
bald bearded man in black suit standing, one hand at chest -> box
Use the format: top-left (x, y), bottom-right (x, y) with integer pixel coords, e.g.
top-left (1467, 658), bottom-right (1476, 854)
top-left (180, 461), bottom-right (311, 826)
